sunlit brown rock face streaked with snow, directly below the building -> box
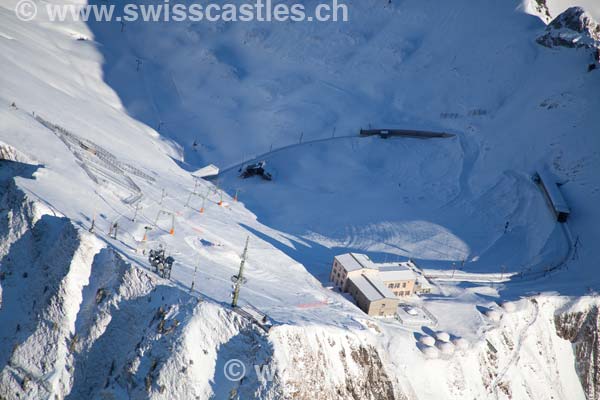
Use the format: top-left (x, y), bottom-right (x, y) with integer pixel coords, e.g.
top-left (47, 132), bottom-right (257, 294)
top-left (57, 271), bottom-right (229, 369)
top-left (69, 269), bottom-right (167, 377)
top-left (270, 327), bottom-right (406, 400)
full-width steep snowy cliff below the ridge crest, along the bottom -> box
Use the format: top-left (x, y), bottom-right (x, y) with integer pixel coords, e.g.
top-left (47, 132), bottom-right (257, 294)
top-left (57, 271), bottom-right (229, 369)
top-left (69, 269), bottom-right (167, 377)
top-left (0, 176), bottom-right (597, 399)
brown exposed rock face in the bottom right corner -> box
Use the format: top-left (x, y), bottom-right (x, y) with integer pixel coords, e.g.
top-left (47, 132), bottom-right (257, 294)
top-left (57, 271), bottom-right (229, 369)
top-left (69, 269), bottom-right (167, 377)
top-left (555, 306), bottom-right (600, 400)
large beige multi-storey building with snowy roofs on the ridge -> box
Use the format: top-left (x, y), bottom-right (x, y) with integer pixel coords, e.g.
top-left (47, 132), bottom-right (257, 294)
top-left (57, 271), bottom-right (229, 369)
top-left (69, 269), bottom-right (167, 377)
top-left (330, 253), bottom-right (424, 316)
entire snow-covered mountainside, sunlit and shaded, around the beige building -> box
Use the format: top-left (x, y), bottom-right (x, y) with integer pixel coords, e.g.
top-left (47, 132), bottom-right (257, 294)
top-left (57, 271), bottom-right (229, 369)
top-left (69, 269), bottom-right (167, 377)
top-left (0, 1), bottom-right (600, 400)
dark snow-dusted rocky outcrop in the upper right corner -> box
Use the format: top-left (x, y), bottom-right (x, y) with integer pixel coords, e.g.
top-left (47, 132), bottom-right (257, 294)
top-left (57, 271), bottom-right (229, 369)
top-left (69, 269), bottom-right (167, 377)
top-left (537, 7), bottom-right (600, 48)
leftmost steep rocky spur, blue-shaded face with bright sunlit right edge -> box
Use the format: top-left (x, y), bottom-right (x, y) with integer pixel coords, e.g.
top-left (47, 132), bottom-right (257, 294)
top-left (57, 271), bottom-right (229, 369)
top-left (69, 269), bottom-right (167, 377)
top-left (0, 180), bottom-right (99, 396)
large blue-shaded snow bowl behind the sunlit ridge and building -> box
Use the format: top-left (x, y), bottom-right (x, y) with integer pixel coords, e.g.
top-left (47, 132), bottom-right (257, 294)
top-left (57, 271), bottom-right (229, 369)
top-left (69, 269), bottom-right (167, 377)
top-left (85, 1), bottom-right (598, 282)
